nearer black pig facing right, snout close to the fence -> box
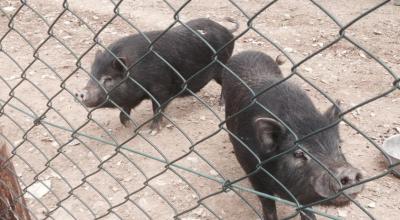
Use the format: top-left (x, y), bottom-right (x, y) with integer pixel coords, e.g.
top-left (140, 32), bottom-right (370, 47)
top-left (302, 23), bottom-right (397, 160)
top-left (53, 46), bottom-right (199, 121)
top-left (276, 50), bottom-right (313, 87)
top-left (222, 51), bottom-right (363, 220)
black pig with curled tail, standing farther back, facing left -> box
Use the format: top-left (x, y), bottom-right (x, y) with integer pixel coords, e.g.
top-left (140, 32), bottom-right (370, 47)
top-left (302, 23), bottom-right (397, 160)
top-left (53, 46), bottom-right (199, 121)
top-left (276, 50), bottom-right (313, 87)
top-left (76, 18), bottom-right (238, 130)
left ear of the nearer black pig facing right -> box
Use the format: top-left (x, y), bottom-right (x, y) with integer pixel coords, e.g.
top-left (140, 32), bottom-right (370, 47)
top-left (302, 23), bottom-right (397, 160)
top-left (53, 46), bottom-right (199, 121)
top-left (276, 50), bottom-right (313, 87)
top-left (254, 118), bottom-right (286, 153)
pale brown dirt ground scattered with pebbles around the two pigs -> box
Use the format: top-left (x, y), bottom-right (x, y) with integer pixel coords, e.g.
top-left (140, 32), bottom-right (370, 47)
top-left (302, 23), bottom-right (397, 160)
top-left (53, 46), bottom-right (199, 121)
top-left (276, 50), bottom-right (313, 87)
top-left (0, 0), bottom-right (400, 220)
